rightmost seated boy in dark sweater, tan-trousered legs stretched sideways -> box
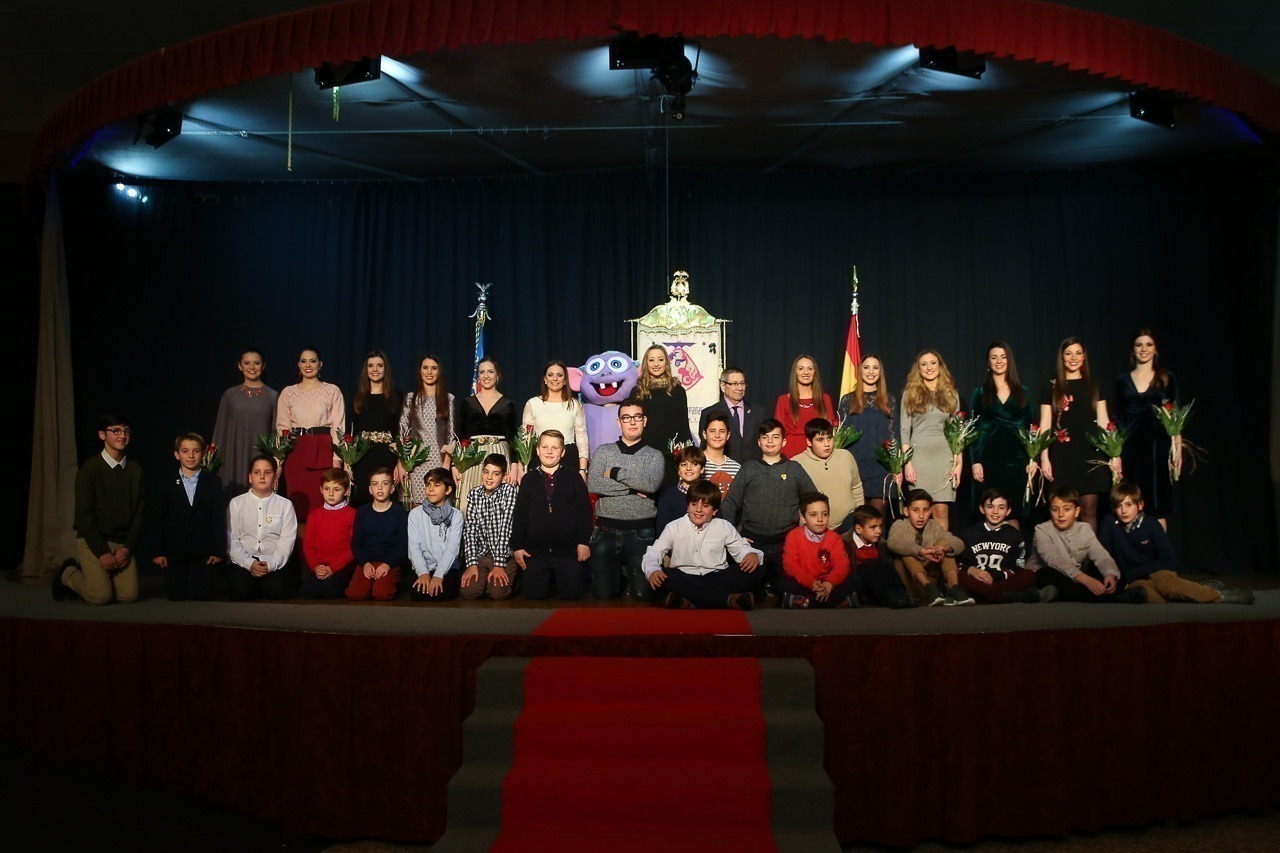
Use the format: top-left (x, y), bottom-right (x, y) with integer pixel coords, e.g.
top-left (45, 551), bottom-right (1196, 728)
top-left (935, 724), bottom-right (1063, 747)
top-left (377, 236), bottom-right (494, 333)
top-left (1098, 480), bottom-right (1253, 605)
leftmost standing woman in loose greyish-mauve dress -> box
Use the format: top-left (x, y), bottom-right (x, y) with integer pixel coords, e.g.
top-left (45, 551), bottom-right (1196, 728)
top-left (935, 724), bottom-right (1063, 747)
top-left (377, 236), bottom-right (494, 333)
top-left (212, 350), bottom-right (280, 500)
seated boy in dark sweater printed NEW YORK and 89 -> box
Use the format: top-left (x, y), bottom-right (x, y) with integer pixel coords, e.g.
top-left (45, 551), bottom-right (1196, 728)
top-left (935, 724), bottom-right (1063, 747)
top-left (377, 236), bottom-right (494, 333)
top-left (956, 489), bottom-right (1057, 605)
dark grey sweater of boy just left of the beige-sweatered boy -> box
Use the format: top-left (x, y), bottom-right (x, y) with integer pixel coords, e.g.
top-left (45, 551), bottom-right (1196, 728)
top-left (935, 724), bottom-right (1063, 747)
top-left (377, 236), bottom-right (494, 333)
top-left (719, 459), bottom-right (817, 543)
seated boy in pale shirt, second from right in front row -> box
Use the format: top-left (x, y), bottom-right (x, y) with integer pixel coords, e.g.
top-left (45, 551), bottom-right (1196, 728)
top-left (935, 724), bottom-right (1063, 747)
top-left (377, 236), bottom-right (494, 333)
top-left (1029, 485), bottom-right (1147, 605)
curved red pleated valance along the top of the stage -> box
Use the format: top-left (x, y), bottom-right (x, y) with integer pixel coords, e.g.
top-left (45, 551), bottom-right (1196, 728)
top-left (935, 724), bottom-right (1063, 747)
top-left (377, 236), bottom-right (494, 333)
top-left (29, 0), bottom-right (1280, 173)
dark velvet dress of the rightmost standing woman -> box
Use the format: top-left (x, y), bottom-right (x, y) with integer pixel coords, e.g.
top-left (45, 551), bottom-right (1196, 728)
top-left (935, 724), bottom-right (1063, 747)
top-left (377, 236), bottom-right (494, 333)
top-left (1111, 373), bottom-right (1181, 516)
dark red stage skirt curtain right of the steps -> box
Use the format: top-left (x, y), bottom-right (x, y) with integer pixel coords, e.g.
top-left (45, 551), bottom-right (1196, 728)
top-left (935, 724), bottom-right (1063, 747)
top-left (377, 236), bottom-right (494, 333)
top-left (812, 617), bottom-right (1280, 847)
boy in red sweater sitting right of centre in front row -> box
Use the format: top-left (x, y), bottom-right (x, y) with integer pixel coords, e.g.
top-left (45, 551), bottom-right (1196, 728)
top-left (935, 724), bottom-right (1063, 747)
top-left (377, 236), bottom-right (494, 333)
top-left (782, 492), bottom-right (859, 610)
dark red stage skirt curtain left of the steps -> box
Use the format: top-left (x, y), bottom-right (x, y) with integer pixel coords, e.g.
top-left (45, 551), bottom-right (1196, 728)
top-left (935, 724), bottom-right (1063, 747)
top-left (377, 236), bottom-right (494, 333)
top-left (0, 620), bottom-right (489, 841)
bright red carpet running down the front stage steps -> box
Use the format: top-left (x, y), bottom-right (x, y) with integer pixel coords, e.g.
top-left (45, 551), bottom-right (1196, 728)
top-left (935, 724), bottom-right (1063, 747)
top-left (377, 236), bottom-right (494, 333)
top-left (493, 653), bottom-right (777, 853)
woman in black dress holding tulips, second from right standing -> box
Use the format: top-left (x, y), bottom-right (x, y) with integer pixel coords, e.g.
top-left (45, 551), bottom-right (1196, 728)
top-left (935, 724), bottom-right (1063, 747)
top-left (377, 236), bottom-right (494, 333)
top-left (1039, 337), bottom-right (1120, 530)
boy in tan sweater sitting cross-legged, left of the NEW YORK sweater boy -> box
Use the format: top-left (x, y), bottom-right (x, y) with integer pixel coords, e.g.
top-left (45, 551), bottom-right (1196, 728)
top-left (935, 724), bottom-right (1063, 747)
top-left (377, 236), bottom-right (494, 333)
top-left (888, 489), bottom-right (973, 607)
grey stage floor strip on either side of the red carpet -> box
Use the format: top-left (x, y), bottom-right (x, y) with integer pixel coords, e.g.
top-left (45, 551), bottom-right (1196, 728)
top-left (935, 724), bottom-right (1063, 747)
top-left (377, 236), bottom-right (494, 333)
top-left (0, 574), bottom-right (1280, 637)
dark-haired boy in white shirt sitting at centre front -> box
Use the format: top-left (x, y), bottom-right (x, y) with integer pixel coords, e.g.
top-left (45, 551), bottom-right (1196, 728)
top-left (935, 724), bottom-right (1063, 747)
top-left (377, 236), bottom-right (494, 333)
top-left (640, 480), bottom-right (764, 610)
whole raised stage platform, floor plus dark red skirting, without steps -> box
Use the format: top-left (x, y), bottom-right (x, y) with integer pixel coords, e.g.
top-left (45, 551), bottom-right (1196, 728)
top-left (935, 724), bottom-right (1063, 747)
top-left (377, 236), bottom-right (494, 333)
top-left (0, 579), bottom-right (1280, 849)
